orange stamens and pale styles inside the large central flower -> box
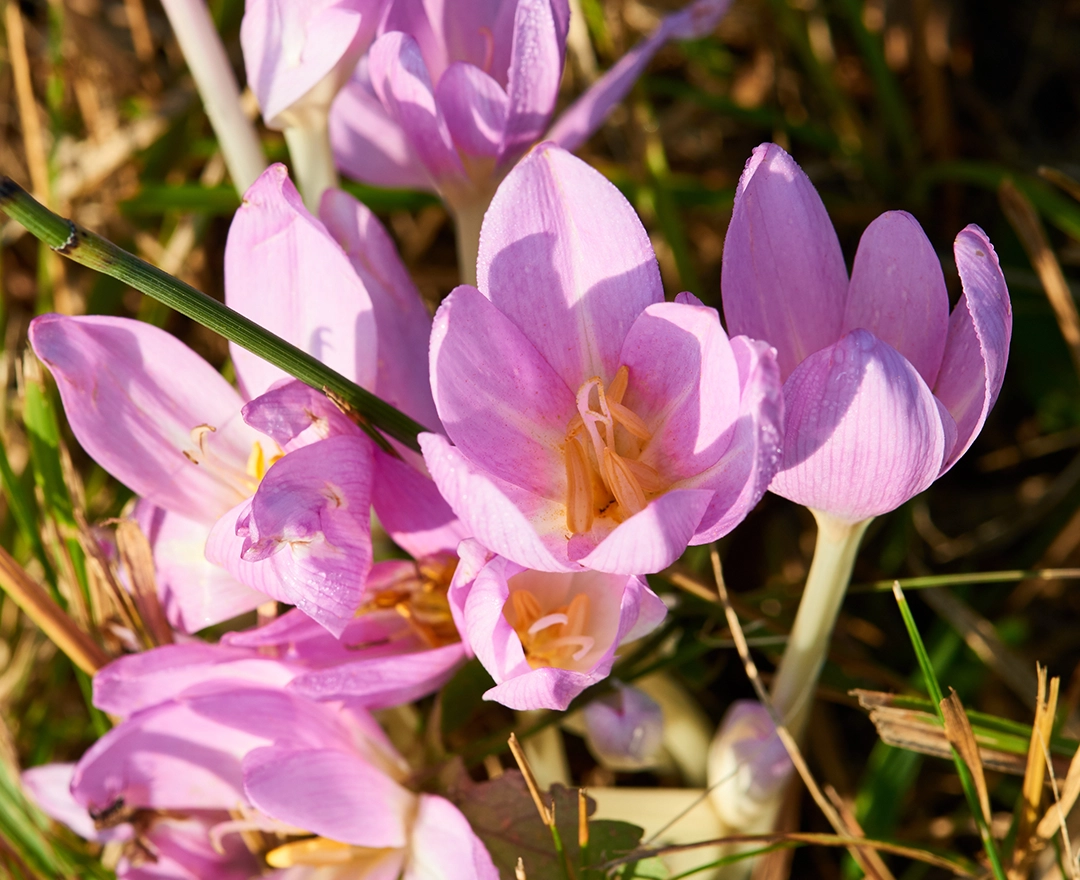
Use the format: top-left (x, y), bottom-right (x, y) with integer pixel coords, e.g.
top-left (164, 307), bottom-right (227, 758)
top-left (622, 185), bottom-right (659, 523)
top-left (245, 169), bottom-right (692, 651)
top-left (565, 365), bottom-right (666, 534)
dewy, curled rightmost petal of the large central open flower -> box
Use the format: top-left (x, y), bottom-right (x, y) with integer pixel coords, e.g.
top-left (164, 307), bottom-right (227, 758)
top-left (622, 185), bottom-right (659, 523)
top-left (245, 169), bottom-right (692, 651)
top-left (683, 336), bottom-right (784, 544)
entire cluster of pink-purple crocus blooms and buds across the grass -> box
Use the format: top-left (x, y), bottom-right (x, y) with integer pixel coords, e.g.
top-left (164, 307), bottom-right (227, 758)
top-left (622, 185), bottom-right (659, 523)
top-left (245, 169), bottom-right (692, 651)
top-left (25, 0), bottom-right (1011, 880)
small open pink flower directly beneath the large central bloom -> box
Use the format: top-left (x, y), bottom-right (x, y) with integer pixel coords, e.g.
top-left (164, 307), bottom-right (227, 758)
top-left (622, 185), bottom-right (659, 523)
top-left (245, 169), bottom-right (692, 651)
top-left (449, 540), bottom-right (666, 710)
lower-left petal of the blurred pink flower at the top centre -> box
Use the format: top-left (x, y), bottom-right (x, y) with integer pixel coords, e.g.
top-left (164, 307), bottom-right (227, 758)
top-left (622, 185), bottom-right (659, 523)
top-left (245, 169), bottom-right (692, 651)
top-left (329, 67), bottom-right (432, 190)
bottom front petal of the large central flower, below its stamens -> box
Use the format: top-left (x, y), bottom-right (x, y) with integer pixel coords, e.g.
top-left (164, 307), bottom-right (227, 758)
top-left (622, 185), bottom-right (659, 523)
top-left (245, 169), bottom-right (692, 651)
top-left (569, 489), bottom-right (714, 574)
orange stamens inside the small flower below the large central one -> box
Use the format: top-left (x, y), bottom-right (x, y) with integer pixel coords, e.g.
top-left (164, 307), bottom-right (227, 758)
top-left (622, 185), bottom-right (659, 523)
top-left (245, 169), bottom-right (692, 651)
top-left (502, 590), bottom-right (596, 669)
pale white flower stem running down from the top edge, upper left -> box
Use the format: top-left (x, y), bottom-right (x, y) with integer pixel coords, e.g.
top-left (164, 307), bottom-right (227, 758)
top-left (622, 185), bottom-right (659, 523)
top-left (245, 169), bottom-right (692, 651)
top-left (161, 0), bottom-right (267, 195)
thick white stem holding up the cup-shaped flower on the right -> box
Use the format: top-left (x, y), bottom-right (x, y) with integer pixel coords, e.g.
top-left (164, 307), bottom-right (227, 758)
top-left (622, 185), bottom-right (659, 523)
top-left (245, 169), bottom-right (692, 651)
top-left (772, 510), bottom-right (873, 739)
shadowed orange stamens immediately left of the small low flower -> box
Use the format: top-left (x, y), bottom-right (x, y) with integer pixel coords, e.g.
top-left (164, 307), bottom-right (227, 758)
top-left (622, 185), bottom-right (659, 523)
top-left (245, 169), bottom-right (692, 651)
top-left (356, 553), bottom-right (461, 648)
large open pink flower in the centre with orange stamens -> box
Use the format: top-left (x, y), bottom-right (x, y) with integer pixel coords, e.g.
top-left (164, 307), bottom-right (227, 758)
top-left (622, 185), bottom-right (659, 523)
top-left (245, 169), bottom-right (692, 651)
top-left (420, 145), bottom-right (782, 574)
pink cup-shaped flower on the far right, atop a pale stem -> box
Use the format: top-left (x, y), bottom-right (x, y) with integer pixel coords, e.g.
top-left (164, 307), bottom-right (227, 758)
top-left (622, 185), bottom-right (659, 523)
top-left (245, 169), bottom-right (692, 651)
top-left (721, 144), bottom-right (1012, 523)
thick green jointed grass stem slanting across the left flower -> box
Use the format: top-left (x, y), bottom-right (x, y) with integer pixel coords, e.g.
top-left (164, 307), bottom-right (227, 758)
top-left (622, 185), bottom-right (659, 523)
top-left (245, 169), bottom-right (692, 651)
top-left (0, 177), bottom-right (428, 451)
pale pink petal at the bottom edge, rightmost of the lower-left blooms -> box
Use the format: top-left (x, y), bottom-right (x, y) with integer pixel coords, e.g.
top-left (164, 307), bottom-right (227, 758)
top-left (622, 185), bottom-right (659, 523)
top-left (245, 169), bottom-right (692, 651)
top-left (402, 795), bottom-right (499, 880)
